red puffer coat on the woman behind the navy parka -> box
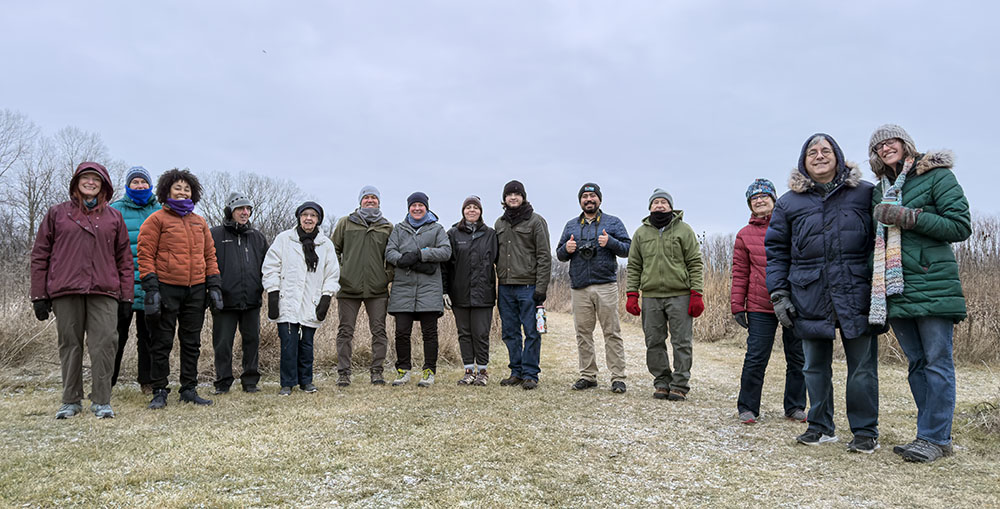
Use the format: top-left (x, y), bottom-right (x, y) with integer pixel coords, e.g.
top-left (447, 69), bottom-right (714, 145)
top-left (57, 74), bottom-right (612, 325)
top-left (729, 216), bottom-right (774, 314)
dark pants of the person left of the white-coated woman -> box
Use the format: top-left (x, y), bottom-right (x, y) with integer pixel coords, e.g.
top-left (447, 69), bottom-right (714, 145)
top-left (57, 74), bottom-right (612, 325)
top-left (212, 308), bottom-right (260, 390)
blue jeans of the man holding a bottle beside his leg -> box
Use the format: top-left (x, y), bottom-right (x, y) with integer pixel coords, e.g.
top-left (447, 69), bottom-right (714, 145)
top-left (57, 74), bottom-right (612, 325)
top-left (497, 285), bottom-right (542, 381)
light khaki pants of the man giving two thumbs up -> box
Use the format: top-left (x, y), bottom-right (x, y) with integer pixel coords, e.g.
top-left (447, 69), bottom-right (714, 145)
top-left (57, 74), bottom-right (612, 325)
top-left (572, 283), bottom-right (625, 382)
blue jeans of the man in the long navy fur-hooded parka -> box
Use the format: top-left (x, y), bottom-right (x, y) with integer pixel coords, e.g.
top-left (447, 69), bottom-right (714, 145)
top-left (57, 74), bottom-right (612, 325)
top-left (802, 335), bottom-right (878, 438)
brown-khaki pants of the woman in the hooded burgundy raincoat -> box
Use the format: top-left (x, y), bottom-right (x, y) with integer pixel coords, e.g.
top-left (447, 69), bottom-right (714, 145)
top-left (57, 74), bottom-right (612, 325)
top-left (52, 295), bottom-right (118, 405)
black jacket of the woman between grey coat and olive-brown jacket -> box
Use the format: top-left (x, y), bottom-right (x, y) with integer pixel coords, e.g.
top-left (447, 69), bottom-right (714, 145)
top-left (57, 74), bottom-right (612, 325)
top-left (442, 222), bottom-right (500, 308)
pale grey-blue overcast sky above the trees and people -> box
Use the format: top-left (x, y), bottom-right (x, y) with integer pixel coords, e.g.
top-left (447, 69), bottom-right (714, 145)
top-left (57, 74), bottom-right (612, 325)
top-left (0, 0), bottom-right (1000, 240)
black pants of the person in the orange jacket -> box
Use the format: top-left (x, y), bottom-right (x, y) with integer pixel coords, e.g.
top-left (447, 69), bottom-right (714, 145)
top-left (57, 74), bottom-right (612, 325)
top-left (149, 283), bottom-right (205, 391)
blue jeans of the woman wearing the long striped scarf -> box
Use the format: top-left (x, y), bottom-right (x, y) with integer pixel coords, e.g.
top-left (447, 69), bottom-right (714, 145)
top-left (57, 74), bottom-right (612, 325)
top-left (889, 316), bottom-right (955, 445)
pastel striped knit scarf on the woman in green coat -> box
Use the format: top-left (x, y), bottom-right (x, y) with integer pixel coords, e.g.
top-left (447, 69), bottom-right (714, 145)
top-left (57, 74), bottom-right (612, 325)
top-left (868, 158), bottom-right (913, 325)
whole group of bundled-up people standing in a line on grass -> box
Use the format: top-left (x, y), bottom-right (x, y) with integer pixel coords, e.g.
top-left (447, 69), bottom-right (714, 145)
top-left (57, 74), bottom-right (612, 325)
top-left (31, 125), bottom-right (971, 461)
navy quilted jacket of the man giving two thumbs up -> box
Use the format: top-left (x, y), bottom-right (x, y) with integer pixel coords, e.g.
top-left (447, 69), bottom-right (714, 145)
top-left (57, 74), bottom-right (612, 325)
top-left (556, 210), bottom-right (632, 288)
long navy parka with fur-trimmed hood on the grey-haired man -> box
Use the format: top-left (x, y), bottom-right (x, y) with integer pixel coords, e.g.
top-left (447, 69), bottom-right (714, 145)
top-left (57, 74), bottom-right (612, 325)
top-left (764, 161), bottom-right (875, 340)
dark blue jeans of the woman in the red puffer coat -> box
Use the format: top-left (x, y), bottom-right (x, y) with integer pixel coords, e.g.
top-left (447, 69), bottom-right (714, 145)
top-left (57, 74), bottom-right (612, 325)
top-left (736, 312), bottom-right (806, 416)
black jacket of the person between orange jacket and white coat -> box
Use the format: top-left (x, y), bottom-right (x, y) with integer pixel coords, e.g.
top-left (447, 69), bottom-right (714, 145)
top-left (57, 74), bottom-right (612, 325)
top-left (211, 220), bottom-right (267, 310)
